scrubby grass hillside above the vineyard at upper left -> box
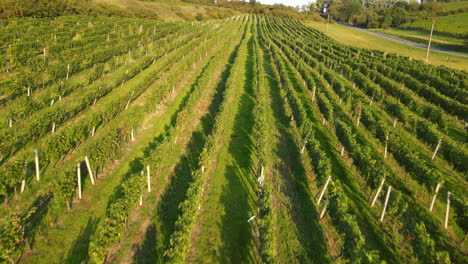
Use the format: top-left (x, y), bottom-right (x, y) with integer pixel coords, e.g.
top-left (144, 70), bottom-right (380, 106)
top-left (0, 0), bottom-right (240, 21)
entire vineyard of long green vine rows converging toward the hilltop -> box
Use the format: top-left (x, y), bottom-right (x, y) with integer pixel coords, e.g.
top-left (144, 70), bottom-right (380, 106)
top-left (0, 15), bottom-right (468, 264)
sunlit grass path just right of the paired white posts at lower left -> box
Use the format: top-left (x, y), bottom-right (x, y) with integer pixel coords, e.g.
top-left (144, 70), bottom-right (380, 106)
top-left (17, 47), bottom-right (208, 263)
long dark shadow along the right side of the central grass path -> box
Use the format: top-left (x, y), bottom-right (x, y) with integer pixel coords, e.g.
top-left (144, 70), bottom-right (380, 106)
top-left (216, 35), bottom-right (256, 263)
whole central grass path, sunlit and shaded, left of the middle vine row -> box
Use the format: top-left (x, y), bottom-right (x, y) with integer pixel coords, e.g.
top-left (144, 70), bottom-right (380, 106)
top-left (189, 21), bottom-right (256, 263)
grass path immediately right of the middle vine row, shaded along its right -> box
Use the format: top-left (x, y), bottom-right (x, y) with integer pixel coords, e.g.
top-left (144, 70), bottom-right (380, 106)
top-left (263, 35), bottom-right (330, 263)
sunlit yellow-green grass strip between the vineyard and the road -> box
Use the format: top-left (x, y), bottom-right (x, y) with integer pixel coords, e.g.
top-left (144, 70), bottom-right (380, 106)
top-left (306, 22), bottom-right (468, 71)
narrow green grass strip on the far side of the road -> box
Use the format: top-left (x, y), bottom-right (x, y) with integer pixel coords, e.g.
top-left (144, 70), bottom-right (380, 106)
top-left (370, 28), bottom-right (468, 54)
